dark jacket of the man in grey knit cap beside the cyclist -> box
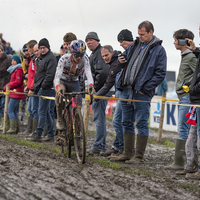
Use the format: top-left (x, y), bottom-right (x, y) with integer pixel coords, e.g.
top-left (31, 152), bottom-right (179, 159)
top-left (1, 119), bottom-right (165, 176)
top-left (90, 44), bottom-right (109, 92)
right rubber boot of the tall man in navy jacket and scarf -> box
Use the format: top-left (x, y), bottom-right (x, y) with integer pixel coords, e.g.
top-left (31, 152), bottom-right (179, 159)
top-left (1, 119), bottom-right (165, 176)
top-left (125, 135), bottom-right (148, 164)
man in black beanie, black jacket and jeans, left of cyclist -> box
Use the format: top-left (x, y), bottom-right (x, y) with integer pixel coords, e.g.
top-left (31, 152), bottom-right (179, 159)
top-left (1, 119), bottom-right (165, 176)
top-left (29, 38), bottom-right (57, 141)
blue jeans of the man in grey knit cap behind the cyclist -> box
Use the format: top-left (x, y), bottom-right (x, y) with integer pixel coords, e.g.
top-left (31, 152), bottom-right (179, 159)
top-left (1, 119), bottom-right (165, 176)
top-left (92, 92), bottom-right (113, 151)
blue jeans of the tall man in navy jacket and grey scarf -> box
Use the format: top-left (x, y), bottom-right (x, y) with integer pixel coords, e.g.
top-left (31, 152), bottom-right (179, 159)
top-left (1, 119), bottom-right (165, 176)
top-left (121, 88), bottom-right (151, 136)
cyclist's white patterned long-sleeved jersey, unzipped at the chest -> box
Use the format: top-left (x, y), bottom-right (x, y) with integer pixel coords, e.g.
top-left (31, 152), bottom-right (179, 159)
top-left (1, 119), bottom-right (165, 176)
top-left (54, 53), bottom-right (94, 87)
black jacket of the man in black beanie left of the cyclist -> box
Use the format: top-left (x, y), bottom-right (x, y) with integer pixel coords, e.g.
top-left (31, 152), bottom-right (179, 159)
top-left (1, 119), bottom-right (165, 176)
top-left (32, 50), bottom-right (57, 93)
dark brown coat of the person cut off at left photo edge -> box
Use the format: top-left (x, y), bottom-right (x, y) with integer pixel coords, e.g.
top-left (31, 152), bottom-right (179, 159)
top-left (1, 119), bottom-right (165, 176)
top-left (0, 52), bottom-right (11, 97)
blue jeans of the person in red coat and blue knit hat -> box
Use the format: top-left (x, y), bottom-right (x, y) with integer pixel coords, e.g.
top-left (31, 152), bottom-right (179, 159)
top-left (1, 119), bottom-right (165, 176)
top-left (8, 98), bottom-right (20, 119)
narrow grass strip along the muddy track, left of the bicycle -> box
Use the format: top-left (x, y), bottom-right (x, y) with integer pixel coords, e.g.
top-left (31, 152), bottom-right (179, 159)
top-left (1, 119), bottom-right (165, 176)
top-left (0, 134), bottom-right (61, 153)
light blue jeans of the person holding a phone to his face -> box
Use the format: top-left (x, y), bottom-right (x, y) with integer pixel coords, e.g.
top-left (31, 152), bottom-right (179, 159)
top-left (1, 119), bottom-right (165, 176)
top-left (178, 96), bottom-right (190, 140)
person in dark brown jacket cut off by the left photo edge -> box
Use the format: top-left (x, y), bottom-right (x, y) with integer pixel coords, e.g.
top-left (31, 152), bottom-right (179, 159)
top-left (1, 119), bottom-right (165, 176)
top-left (0, 45), bottom-right (11, 130)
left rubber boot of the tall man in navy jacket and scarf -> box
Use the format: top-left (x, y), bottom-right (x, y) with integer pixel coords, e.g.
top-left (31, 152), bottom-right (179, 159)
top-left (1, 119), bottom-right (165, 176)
top-left (110, 133), bottom-right (135, 162)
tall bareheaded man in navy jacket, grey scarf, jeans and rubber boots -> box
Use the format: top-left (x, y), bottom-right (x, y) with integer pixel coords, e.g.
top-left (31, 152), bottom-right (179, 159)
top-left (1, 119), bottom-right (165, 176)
top-left (111, 21), bottom-right (167, 163)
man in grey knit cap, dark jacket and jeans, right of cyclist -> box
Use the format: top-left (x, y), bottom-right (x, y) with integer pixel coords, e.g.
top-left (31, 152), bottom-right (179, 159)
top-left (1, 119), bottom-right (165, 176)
top-left (85, 32), bottom-right (110, 154)
